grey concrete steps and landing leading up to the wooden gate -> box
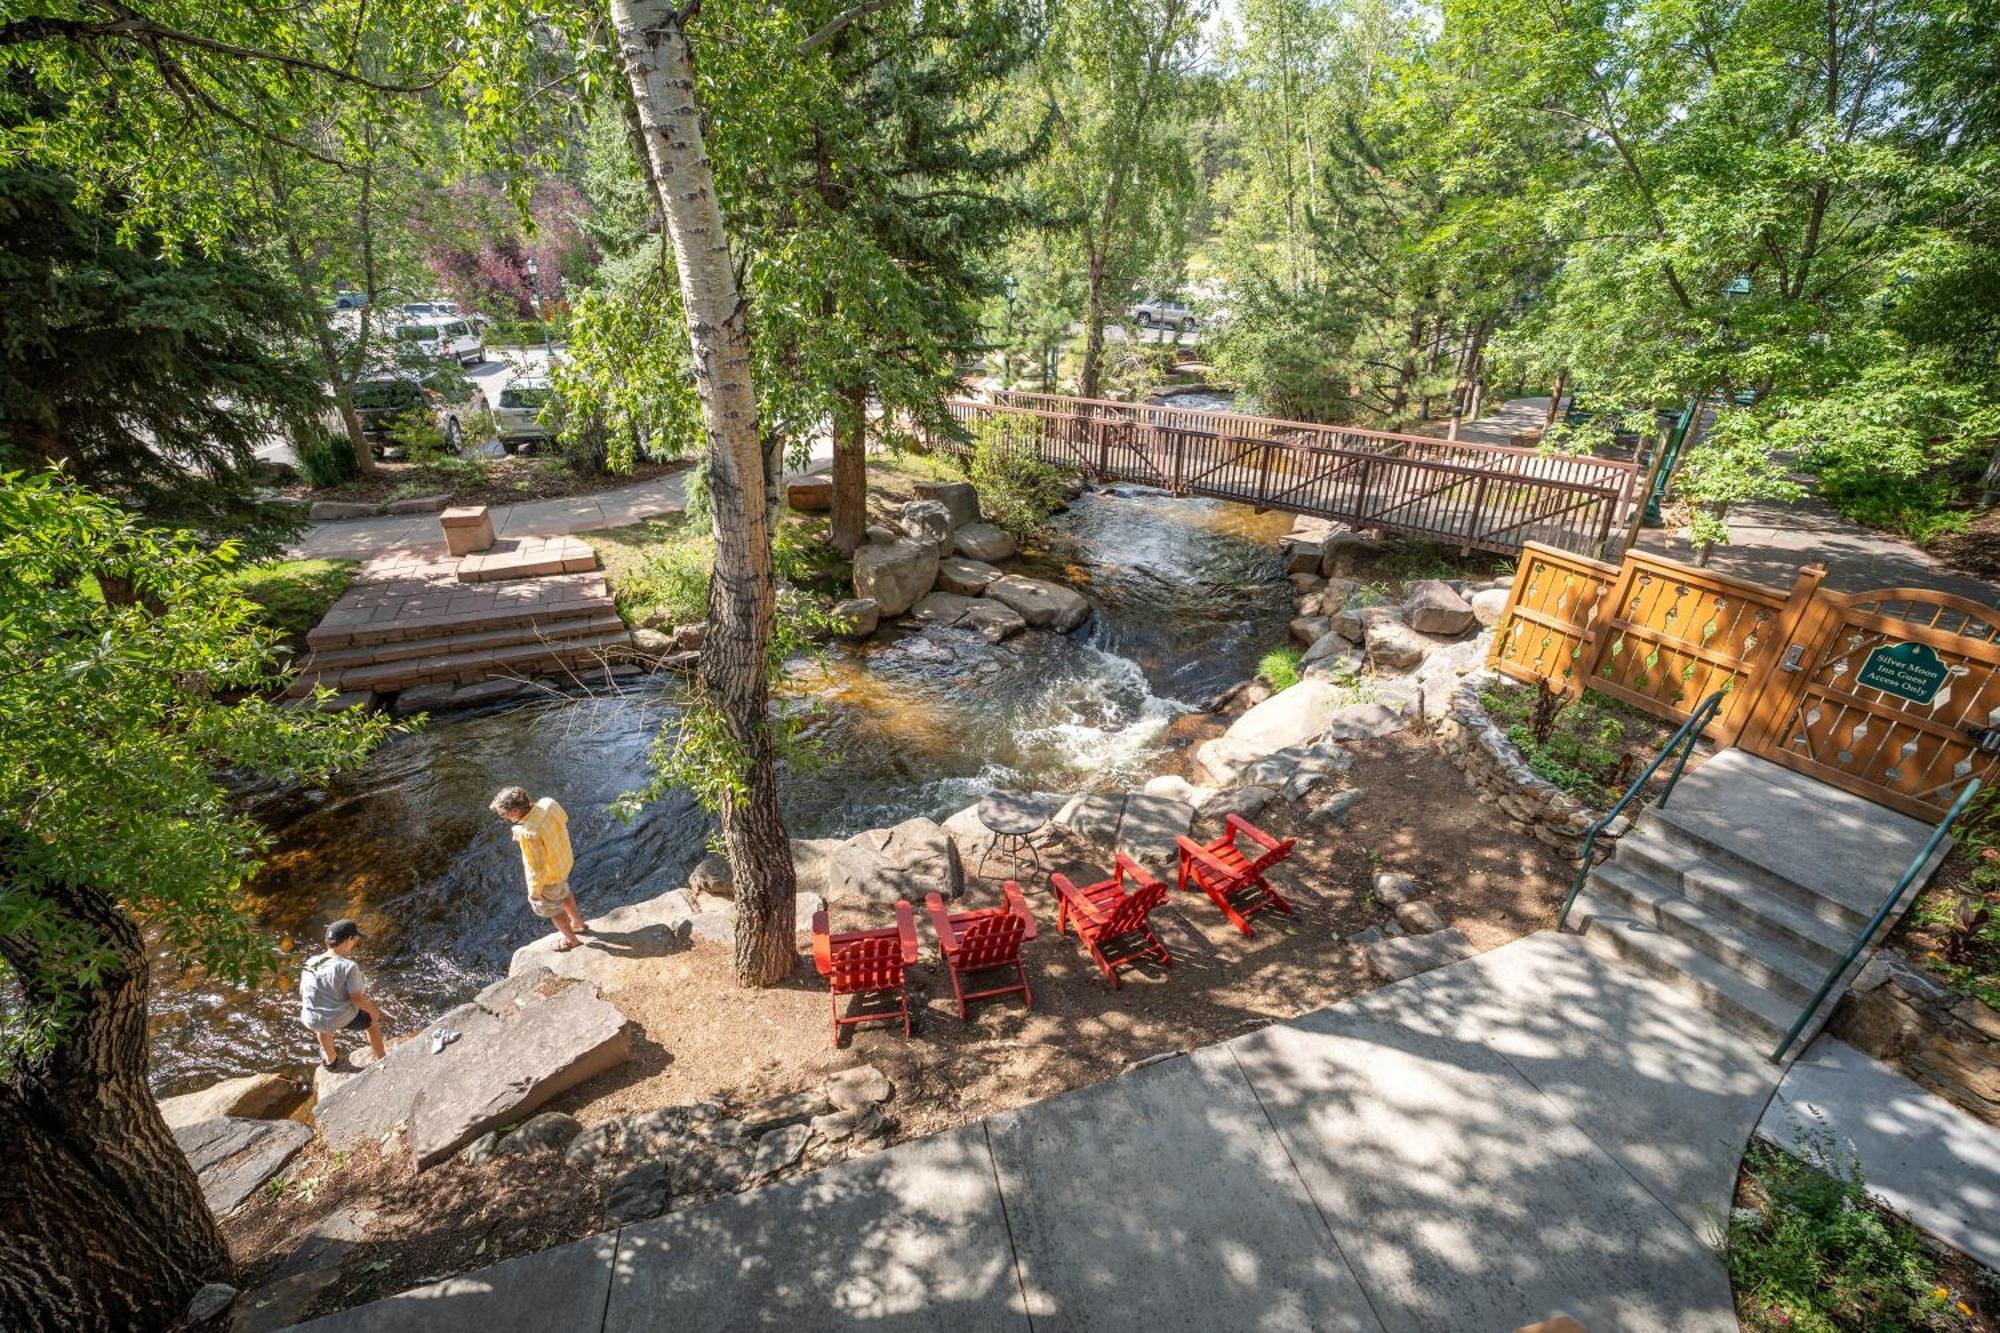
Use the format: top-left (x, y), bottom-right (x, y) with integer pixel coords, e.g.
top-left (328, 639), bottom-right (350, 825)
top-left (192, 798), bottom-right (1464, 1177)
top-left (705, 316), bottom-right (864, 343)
top-left (1568, 751), bottom-right (1942, 1049)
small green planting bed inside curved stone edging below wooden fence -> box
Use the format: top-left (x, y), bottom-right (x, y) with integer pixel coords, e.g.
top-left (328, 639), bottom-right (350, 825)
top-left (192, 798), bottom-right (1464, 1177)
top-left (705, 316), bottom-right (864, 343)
top-left (1480, 681), bottom-right (1680, 811)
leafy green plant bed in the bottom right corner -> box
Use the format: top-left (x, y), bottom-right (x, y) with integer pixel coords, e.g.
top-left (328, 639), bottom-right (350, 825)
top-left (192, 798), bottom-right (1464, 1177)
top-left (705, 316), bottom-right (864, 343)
top-left (1722, 1139), bottom-right (1992, 1333)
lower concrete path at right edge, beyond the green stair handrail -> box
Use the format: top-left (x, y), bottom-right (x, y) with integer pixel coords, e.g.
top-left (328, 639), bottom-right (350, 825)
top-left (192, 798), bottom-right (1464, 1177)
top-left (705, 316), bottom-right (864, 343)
top-left (1758, 1037), bottom-right (2000, 1271)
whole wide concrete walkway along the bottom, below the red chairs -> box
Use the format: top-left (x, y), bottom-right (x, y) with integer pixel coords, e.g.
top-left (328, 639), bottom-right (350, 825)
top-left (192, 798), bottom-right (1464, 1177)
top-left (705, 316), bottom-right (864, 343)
top-left (286, 931), bottom-right (1776, 1333)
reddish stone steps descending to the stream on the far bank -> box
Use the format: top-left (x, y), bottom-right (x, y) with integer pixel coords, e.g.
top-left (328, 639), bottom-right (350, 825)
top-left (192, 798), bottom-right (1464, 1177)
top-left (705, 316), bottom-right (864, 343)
top-left (294, 572), bottom-right (632, 695)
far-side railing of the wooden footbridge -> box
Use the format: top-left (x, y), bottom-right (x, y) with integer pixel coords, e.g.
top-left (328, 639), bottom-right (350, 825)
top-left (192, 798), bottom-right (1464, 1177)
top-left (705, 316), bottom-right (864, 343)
top-left (994, 388), bottom-right (1640, 500)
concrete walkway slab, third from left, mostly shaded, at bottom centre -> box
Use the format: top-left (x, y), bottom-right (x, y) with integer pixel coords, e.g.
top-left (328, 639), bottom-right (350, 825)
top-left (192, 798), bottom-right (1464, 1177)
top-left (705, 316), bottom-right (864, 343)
top-left (988, 1047), bottom-right (1380, 1333)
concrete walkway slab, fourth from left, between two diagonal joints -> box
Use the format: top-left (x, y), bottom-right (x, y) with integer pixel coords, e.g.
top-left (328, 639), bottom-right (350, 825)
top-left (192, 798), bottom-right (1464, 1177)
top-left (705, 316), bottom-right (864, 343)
top-left (1224, 964), bottom-right (1736, 1333)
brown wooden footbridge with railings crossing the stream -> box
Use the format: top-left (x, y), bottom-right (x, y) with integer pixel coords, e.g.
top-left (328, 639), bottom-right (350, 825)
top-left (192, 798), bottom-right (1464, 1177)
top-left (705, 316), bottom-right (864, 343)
top-left (928, 390), bottom-right (1638, 556)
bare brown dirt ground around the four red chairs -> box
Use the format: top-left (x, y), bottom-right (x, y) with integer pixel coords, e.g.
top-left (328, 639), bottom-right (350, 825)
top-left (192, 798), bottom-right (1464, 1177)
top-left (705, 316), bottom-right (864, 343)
top-left (224, 735), bottom-right (1574, 1313)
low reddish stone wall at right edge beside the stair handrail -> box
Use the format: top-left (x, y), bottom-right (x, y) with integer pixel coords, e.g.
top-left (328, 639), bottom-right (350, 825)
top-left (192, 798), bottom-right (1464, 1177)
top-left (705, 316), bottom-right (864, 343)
top-left (1828, 949), bottom-right (2000, 1125)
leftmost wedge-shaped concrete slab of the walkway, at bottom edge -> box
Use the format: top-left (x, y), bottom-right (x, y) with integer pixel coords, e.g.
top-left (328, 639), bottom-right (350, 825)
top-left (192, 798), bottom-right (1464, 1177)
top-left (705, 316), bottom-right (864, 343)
top-left (278, 1231), bottom-right (612, 1333)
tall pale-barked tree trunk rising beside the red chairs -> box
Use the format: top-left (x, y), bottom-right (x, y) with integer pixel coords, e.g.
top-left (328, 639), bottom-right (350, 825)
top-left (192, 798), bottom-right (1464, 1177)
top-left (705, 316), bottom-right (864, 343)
top-left (610, 0), bottom-right (798, 987)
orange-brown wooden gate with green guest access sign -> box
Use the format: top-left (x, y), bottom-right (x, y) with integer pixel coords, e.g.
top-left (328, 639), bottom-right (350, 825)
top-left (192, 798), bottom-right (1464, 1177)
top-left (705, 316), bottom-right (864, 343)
top-left (1740, 588), bottom-right (2000, 819)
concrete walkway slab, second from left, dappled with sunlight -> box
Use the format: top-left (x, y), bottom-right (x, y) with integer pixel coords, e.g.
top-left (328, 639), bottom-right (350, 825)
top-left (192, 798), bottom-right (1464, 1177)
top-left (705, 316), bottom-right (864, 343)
top-left (600, 1125), bottom-right (1024, 1333)
